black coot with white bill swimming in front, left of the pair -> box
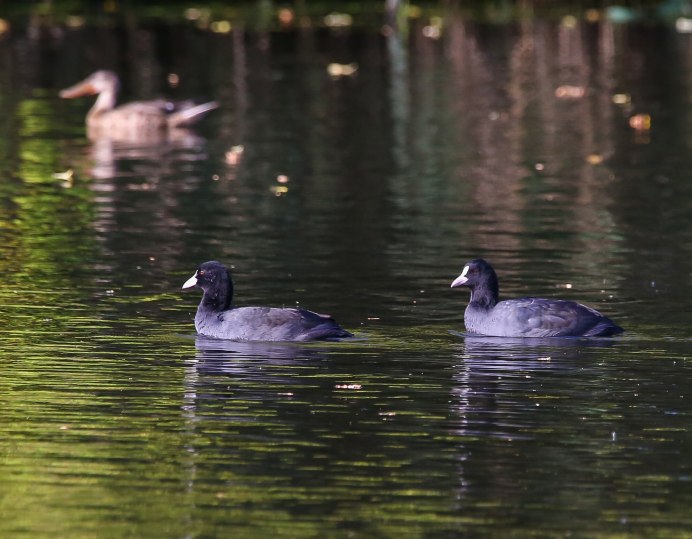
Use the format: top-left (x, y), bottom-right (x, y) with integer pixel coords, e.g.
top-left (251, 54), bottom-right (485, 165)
top-left (183, 260), bottom-right (353, 341)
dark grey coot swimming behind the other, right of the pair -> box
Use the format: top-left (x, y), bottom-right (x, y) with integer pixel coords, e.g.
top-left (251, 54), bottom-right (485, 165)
top-left (452, 258), bottom-right (623, 337)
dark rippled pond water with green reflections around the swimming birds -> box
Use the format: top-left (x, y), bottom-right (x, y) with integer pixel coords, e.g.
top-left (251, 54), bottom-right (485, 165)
top-left (0, 5), bottom-right (692, 538)
